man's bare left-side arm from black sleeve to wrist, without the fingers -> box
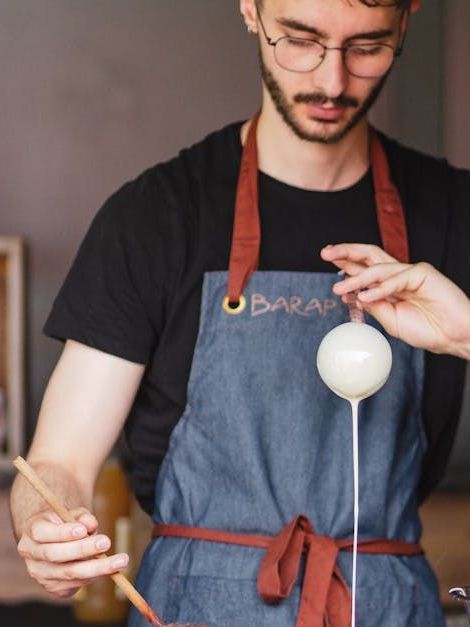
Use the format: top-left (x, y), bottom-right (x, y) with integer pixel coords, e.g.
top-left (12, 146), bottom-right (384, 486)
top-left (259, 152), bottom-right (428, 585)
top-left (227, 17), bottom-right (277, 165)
top-left (11, 342), bottom-right (144, 537)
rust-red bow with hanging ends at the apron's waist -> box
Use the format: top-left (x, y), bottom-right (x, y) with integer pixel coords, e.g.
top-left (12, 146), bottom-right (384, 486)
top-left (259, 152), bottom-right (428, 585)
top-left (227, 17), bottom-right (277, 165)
top-left (258, 515), bottom-right (351, 627)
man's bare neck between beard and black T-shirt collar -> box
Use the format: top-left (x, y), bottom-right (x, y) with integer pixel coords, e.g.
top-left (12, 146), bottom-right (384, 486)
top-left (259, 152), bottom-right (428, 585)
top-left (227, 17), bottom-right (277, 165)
top-left (242, 104), bottom-right (369, 191)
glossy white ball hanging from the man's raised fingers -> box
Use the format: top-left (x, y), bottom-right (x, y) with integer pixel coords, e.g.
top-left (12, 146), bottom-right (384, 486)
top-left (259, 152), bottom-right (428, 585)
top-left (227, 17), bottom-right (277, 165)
top-left (317, 322), bottom-right (392, 400)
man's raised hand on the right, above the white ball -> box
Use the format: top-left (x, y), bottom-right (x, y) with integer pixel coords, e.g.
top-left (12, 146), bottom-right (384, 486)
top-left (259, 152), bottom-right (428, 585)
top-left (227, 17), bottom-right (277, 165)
top-left (321, 244), bottom-right (470, 359)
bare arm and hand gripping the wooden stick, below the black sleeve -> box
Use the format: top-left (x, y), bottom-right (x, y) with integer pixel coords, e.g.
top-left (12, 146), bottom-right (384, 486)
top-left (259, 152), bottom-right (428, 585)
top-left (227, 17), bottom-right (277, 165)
top-left (10, 340), bottom-right (145, 598)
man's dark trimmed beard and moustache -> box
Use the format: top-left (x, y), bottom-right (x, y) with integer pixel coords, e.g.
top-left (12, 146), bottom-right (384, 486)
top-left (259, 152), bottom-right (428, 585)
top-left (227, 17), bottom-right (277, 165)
top-left (259, 51), bottom-right (390, 144)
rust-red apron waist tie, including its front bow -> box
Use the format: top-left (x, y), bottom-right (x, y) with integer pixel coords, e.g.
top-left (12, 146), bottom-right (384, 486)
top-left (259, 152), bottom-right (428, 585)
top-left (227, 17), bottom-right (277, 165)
top-left (152, 515), bottom-right (424, 627)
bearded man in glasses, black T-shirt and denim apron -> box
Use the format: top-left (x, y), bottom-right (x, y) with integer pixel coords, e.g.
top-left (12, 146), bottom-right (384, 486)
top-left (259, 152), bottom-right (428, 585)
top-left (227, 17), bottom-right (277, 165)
top-left (12, 0), bottom-right (470, 627)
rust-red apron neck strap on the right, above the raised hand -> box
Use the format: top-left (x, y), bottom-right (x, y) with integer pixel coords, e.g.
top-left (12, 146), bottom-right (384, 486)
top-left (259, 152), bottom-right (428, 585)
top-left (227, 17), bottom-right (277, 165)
top-left (369, 127), bottom-right (410, 263)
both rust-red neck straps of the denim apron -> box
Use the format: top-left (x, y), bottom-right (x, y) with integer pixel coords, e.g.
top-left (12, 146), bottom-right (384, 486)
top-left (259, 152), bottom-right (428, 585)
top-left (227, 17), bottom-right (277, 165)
top-left (227, 112), bottom-right (409, 305)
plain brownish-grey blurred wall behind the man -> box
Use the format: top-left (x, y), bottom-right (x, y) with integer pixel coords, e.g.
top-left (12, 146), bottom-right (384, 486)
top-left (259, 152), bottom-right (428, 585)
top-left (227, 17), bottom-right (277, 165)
top-left (0, 0), bottom-right (470, 485)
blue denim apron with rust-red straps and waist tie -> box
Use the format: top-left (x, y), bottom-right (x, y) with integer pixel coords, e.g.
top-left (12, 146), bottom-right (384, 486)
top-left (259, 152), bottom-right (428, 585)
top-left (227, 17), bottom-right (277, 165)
top-left (129, 118), bottom-right (444, 627)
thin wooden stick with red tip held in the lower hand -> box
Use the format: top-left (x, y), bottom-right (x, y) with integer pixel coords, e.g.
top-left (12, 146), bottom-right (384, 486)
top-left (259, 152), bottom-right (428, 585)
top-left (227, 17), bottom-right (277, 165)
top-left (13, 457), bottom-right (165, 627)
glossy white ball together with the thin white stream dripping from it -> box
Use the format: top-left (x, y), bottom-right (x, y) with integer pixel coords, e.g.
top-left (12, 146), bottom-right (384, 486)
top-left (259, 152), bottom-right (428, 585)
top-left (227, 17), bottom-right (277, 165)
top-left (317, 322), bottom-right (392, 627)
